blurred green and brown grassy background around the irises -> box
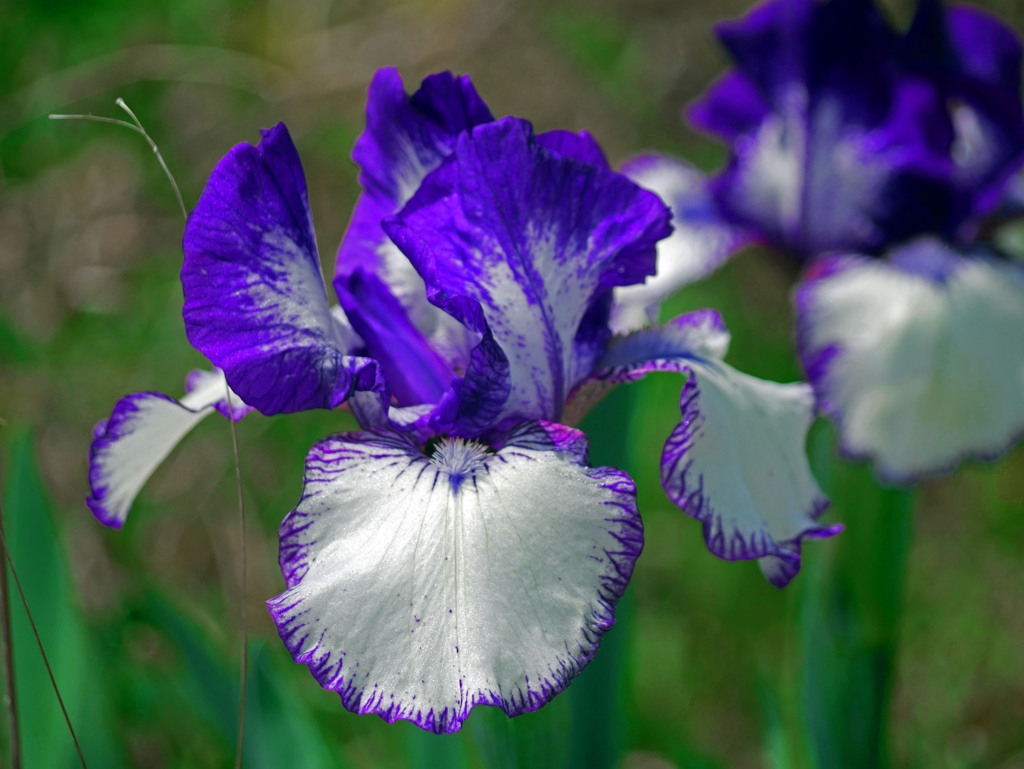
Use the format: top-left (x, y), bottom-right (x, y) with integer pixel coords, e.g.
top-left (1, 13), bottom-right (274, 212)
top-left (0, 0), bottom-right (1024, 769)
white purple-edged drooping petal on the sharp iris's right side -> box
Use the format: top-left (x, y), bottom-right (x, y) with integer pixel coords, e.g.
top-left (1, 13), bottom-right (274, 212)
top-left (595, 310), bottom-right (842, 588)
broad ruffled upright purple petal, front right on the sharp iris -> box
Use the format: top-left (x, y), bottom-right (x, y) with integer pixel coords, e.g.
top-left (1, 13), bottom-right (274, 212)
top-left (385, 118), bottom-right (671, 428)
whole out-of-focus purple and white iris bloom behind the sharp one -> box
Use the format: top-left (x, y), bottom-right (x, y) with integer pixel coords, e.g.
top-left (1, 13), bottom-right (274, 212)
top-left (624, 0), bottom-right (1024, 482)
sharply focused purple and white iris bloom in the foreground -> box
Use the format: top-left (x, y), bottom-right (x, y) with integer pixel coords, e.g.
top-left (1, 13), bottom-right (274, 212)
top-left (90, 70), bottom-right (839, 732)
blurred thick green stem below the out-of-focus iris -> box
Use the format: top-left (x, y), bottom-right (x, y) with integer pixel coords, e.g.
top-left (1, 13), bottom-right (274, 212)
top-left (799, 423), bottom-right (914, 769)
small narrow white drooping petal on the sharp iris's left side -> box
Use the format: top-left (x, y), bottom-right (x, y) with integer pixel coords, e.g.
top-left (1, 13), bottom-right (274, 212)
top-left (86, 370), bottom-right (252, 528)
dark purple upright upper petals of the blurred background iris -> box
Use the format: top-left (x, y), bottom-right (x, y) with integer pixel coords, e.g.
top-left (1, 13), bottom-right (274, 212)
top-left (687, 0), bottom-right (1024, 259)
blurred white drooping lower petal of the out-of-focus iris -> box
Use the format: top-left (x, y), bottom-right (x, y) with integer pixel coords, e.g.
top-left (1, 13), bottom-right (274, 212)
top-left (796, 239), bottom-right (1024, 483)
